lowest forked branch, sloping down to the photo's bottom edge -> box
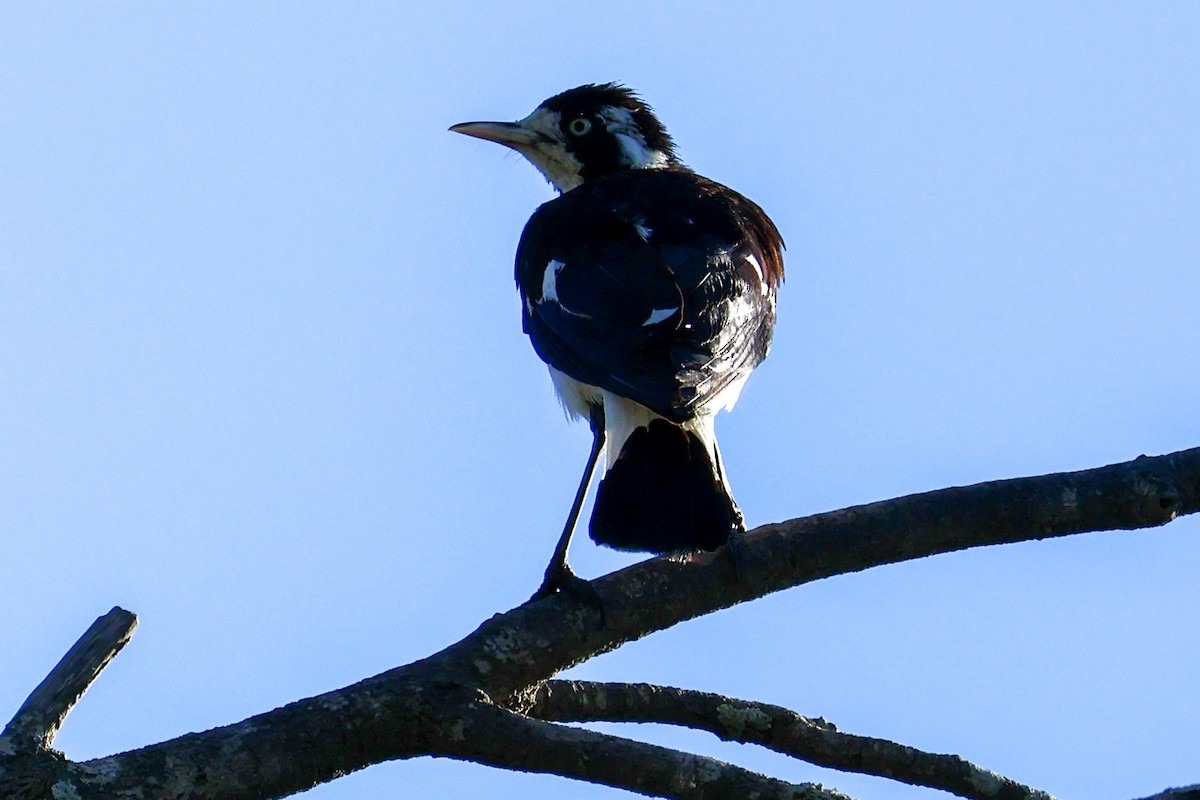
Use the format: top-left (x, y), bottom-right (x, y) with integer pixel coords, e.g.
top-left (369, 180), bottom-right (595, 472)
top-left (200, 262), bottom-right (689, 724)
top-left (439, 703), bottom-right (848, 800)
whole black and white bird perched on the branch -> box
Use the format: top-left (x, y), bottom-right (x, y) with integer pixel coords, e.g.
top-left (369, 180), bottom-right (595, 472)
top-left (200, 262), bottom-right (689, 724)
top-left (450, 83), bottom-right (784, 597)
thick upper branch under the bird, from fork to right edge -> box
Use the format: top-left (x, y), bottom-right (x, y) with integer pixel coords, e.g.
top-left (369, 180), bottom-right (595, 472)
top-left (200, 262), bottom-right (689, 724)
top-left (451, 447), bottom-right (1200, 697)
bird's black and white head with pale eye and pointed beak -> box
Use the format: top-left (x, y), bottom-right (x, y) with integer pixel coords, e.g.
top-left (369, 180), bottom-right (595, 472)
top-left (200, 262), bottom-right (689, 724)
top-left (450, 83), bottom-right (679, 192)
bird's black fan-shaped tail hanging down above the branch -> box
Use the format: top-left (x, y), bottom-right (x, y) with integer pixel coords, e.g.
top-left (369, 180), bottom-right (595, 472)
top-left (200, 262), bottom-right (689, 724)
top-left (589, 420), bottom-right (744, 553)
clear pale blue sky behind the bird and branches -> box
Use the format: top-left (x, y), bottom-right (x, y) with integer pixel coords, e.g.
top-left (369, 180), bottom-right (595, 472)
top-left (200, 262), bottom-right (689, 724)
top-left (0, 1), bottom-right (1200, 800)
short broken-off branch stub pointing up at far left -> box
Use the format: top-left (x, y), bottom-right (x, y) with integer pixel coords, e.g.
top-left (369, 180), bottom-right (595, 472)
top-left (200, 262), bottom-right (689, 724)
top-left (0, 607), bottom-right (138, 754)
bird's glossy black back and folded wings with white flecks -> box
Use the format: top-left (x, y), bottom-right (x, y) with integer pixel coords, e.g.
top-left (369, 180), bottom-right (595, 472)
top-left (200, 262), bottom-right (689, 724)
top-left (516, 169), bottom-right (782, 421)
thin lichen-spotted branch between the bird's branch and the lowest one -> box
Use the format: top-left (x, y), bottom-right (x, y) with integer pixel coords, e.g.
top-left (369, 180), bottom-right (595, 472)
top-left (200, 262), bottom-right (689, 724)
top-left (528, 680), bottom-right (1054, 800)
